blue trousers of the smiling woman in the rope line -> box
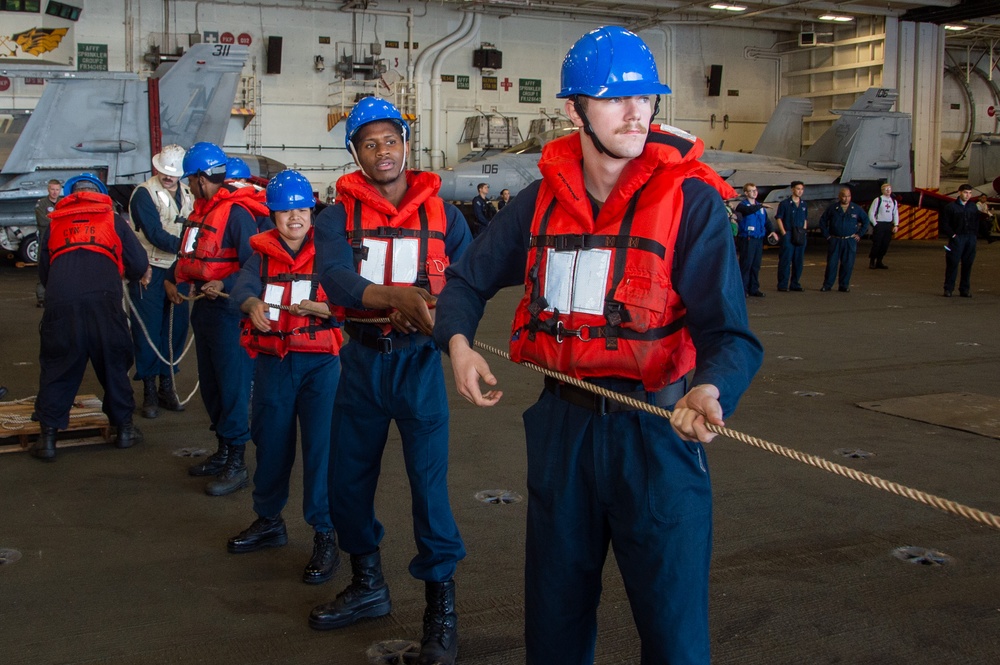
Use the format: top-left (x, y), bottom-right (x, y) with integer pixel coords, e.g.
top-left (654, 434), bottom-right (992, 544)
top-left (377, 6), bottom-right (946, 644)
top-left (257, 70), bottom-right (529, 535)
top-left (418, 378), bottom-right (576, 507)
top-left (250, 352), bottom-right (340, 533)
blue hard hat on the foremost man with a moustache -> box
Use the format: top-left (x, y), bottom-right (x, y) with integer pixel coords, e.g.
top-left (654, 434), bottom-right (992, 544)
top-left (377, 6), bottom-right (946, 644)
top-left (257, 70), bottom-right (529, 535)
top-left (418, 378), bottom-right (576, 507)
top-left (556, 25), bottom-right (670, 98)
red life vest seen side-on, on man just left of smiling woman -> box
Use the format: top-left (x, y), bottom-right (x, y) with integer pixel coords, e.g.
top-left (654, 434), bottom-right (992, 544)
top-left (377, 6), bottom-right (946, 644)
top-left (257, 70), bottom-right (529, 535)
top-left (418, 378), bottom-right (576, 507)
top-left (174, 187), bottom-right (268, 283)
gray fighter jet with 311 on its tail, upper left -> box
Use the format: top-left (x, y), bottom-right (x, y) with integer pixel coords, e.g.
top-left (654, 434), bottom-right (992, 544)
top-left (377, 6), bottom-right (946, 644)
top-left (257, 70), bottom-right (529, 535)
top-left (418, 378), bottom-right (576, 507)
top-left (0, 44), bottom-right (247, 261)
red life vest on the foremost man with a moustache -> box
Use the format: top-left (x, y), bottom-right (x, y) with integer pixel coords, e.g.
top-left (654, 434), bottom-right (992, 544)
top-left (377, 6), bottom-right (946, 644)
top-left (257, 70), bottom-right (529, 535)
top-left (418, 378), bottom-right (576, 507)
top-left (510, 125), bottom-right (736, 391)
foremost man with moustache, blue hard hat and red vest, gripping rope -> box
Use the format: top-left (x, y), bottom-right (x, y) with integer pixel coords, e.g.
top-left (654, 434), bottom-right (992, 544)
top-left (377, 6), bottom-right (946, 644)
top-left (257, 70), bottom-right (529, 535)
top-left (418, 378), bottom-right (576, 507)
top-left (434, 26), bottom-right (762, 665)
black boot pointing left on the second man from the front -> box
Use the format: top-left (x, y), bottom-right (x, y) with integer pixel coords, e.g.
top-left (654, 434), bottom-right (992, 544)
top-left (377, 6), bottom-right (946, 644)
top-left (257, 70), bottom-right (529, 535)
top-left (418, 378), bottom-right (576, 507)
top-left (309, 550), bottom-right (392, 630)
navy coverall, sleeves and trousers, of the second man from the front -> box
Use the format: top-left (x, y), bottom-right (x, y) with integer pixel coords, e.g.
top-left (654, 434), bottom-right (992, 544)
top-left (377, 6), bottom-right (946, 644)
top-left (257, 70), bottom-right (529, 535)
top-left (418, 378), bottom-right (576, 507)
top-left (315, 196), bottom-right (471, 582)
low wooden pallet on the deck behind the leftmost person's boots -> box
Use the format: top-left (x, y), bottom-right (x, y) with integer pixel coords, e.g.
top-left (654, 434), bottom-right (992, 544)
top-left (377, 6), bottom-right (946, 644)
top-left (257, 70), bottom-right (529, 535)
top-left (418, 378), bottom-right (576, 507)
top-left (0, 395), bottom-right (111, 454)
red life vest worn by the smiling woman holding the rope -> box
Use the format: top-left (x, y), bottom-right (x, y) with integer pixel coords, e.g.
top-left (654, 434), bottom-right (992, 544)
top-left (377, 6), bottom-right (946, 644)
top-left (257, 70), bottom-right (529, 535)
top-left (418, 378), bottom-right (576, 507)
top-left (240, 229), bottom-right (343, 358)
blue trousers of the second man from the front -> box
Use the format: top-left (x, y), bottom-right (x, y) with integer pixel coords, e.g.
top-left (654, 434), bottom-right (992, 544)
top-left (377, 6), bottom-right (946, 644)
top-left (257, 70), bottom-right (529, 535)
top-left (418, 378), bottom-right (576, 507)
top-left (329, 336), bottom-right (465, 582)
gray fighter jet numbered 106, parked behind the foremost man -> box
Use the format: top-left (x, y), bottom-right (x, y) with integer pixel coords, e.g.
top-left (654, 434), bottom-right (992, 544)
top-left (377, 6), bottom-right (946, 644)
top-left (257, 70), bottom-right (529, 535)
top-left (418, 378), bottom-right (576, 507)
top-left (437, 88), bottom-right (913, 216)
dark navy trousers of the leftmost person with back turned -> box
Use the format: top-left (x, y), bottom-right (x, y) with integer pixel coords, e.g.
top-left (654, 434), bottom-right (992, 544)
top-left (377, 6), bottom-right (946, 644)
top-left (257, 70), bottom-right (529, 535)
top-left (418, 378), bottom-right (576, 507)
top-left (35, 292), bottom-right (135, 429)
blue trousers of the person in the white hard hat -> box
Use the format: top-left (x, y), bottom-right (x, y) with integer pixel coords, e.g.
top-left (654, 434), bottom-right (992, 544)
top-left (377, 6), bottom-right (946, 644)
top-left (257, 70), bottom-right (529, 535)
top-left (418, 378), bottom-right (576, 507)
top-left (128, 266), bottom-right (190, 381)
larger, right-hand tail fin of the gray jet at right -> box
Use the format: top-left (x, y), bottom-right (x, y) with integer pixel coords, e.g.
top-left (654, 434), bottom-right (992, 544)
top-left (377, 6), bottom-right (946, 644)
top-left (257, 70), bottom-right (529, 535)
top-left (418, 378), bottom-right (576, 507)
top-left (799, 88), bottom-right (913, 192)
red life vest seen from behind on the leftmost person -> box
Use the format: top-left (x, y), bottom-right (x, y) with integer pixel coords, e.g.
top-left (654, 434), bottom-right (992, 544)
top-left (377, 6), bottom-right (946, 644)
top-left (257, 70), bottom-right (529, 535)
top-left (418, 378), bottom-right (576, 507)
top-left (48, 192), bottom-right (125, 275)
